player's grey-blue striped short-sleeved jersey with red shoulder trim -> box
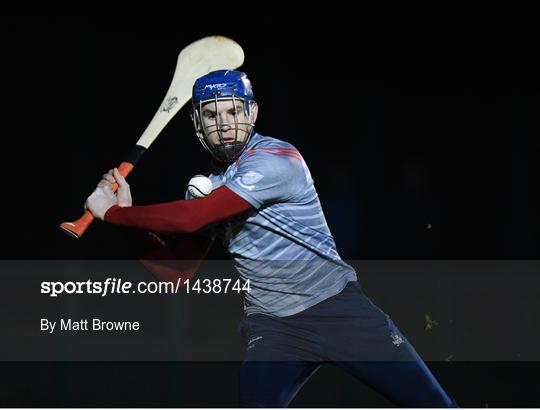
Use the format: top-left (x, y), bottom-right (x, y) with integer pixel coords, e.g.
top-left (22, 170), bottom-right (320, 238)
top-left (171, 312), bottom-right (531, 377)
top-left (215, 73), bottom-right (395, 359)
top-left (188, 134), bottom-right (356, 317)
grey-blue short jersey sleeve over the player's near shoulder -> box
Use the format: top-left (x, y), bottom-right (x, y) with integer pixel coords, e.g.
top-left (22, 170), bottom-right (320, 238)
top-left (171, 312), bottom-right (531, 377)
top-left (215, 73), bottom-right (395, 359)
top-left (225, 149), bottom-right (309, 209)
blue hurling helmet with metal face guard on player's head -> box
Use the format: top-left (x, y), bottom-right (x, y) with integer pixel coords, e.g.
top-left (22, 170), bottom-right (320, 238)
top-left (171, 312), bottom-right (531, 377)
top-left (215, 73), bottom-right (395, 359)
top-left (191, 70), bottom-right (255, 164)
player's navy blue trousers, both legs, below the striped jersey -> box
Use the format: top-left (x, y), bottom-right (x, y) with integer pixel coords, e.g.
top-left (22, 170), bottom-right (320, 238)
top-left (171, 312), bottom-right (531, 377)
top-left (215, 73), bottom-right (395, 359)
top-left (240, 282), bottom-right (458, 407)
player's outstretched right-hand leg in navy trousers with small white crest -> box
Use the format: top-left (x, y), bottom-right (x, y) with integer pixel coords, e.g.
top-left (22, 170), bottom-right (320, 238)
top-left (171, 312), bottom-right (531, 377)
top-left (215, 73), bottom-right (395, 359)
top-left (326, 287), bottom-right (457, 407)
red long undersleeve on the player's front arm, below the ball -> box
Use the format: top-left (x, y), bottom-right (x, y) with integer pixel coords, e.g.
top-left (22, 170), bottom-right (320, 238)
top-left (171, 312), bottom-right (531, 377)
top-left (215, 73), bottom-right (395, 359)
top-left (104, 186), bottom-right (253, 233)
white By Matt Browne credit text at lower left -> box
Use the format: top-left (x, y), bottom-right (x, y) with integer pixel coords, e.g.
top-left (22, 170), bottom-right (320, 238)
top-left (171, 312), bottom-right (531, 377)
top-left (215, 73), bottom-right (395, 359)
top-left (41, 318), bottom-right (141, 333)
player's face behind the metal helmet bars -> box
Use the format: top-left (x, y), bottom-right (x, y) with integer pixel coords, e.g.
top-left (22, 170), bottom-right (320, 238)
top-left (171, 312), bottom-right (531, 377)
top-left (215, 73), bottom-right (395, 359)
top-left (201, 99), bottom-right (257, 145)
